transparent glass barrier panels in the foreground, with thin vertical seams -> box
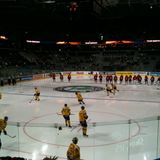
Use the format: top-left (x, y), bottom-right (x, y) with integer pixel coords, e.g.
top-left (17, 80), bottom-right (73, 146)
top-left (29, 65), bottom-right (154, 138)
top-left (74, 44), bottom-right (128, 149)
top-left (0, 116), bottom-right (160, 160)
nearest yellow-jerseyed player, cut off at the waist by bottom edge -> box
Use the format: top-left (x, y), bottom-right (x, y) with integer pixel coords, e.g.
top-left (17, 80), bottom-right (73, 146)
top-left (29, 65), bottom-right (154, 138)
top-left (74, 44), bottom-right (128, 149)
top-left (67, 137), bottom-right (80, 160)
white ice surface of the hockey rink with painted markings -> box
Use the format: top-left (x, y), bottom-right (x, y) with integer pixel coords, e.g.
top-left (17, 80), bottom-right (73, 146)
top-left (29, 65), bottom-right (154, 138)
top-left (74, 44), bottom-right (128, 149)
top-left (0, 77), bottom-right (160, 160)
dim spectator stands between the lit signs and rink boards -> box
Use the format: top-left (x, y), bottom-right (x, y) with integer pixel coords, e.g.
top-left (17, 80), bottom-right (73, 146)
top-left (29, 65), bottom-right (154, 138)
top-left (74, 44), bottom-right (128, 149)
top-left (0, 41), bottom-right (160, 77)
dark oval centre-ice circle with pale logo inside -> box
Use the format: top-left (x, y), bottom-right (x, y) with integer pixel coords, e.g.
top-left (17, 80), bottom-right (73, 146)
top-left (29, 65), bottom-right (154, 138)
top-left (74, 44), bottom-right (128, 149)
top-left (54, 85), bottom-right (104, 92)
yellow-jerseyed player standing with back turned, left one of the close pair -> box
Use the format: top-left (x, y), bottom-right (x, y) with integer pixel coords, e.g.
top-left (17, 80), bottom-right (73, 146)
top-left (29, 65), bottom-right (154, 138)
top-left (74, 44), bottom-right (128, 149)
top-left (61, 104), bottom-right (71, 127)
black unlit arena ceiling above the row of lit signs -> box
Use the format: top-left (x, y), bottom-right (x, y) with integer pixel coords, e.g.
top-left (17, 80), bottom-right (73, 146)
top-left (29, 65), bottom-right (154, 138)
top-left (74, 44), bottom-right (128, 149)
top-left (0, 0), bottom-right (160, 39)
